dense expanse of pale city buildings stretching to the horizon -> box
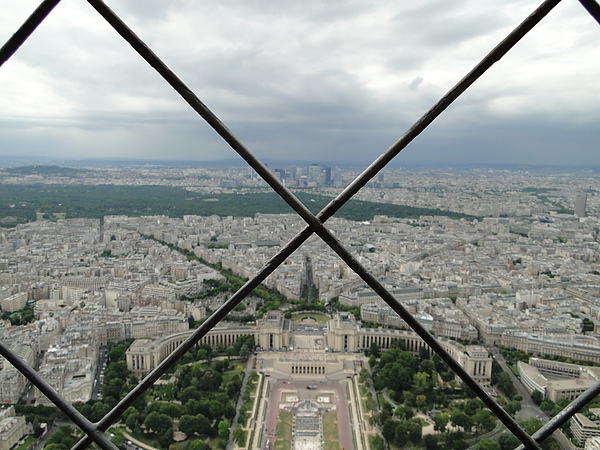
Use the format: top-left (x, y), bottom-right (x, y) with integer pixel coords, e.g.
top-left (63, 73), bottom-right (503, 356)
top-left (0, 165), bottom-right (600, 448)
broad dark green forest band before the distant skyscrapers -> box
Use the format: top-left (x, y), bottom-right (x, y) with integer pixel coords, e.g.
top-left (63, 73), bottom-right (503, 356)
top-left (0, 184), bottom-right (476, 226)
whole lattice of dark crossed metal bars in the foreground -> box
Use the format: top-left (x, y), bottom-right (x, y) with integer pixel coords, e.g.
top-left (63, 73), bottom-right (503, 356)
top-left (0, 0), bottom-right (600, 449)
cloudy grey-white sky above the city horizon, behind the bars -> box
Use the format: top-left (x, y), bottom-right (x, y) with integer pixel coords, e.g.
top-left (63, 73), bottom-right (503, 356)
top-left (0, 0), bottom-right (600, 166)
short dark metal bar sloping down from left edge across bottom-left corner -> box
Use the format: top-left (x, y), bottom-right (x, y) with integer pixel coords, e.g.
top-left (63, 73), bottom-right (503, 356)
top-left (0, 342), bottom-right (117, 450)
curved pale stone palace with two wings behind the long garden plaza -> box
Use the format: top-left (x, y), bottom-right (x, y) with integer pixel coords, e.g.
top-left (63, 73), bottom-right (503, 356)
top-left (127, 311), bottom-right (492, 385)
